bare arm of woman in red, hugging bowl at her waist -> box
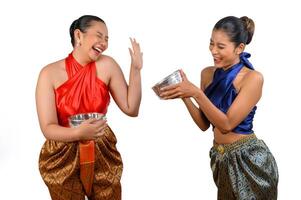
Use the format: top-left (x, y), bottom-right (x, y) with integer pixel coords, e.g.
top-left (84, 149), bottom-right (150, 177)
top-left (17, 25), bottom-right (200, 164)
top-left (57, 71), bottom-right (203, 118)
top-left (36, 66), bottom-right (105, 142)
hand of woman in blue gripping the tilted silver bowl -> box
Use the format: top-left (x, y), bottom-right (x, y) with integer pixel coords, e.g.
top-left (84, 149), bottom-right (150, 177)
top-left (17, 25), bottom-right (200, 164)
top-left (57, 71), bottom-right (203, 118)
top-left (160, 70), bottom-right (200, 100)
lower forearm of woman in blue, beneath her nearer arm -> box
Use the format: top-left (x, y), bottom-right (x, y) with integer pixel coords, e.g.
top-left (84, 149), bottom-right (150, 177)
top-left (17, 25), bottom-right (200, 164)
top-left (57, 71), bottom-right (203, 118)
top-left (182, 98), bottom-right (210, 131)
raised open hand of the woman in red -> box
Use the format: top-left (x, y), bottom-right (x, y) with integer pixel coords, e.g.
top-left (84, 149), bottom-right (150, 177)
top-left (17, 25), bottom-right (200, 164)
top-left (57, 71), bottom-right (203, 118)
top-left (129, 38), bottom-right (143, 70)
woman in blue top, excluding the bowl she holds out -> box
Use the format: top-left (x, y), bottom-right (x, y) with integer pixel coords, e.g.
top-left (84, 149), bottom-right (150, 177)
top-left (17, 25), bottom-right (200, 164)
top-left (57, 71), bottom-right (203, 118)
top-left (161, 16), bottom-right (278, 200)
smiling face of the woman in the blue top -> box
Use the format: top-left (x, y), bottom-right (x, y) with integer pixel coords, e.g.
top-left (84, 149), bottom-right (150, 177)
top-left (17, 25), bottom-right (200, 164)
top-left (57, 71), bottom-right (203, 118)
top-left (209, 29), bottom-right (244, 69)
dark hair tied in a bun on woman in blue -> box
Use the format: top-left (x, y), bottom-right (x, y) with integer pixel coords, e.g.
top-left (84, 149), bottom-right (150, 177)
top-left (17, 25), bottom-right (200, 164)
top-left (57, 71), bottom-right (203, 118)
top-left (213, 16), bottom-right (255, 46)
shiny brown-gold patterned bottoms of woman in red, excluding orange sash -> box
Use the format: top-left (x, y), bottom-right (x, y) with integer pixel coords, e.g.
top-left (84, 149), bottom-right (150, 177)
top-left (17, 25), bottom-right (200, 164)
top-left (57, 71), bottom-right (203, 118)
top-left (39, 127), bottom-right (123, 200)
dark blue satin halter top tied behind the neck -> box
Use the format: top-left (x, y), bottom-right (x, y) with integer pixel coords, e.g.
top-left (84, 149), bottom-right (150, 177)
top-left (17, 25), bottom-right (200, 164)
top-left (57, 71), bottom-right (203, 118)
top-left (205, 52), bottom-right (257, 134)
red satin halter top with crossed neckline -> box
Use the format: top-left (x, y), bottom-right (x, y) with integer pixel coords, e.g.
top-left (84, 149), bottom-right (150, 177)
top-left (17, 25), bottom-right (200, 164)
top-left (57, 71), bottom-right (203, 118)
top-left (55, 53), bottom-right (110, 127)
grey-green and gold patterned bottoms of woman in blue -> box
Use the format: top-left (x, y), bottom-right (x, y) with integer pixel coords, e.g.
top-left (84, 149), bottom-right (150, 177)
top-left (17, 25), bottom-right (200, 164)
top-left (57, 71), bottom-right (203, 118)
top-left (210, 134), bottom-right (278, 200)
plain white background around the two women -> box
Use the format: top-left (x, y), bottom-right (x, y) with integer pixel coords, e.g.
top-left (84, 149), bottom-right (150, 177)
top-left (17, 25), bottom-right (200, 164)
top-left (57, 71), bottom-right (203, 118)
top-left (0, 0), bottom-right (301, 200)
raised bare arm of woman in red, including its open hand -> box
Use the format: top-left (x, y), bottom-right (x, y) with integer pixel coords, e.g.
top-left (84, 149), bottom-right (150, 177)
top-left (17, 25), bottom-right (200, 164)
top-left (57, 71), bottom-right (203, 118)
top-left (109, 39), bottom-right (142, 117)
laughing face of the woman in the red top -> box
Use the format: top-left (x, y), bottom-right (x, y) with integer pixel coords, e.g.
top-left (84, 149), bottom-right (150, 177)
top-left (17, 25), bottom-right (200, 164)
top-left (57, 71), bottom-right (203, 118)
top-left (74, 21), bottom-right (109, 62)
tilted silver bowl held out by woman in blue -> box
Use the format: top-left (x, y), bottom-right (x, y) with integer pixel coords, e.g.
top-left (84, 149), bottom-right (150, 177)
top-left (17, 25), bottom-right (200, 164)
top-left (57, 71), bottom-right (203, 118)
top-left (152, 70), bottom-right (183, 96)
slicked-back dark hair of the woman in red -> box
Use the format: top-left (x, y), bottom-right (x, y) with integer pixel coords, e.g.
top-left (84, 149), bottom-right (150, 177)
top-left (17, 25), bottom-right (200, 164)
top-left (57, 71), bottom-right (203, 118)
top-left (69, 15), bottom-right (106, 46)
